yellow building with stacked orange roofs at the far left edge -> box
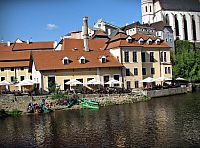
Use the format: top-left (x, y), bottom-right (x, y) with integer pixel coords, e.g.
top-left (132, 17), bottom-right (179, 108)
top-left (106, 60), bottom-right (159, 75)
top-left (0, 39), bottom-right (54, 90)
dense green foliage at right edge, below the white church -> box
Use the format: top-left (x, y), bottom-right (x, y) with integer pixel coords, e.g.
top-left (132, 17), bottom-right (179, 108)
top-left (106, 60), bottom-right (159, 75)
top-left (171, 40), bottom-right (200, 82)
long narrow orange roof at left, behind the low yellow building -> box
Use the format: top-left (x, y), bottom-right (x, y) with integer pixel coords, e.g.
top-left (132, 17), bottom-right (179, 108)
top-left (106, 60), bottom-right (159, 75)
top-left (12, 42), bottom-right (54, 51)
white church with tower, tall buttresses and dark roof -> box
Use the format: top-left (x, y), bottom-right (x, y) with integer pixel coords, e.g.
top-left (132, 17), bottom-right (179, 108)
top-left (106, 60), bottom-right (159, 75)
top-left (141, 0), bottom-right (200, 42)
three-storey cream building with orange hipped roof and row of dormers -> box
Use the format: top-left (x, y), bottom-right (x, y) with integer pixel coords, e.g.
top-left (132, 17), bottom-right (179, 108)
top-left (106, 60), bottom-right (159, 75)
top-left (106, 33), bottom-right (172, 88)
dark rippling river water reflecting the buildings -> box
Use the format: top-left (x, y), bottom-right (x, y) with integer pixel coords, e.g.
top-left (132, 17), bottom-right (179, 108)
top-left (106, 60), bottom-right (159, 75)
top-left (0, 92), bottom-right (200, 148)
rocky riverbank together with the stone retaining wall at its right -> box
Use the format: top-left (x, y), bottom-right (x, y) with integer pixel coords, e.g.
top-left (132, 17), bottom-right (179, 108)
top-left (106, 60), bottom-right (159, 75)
top-left (0, 87), bottom-right (192, 113)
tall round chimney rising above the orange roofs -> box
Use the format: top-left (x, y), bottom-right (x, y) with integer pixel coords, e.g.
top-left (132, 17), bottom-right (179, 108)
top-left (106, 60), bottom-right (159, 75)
top-left (82, 16), bottom-right (89, 51)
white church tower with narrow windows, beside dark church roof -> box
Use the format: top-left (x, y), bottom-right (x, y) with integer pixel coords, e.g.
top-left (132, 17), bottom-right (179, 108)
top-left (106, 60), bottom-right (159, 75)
top-left (141, 0), bottom-right (154, 24)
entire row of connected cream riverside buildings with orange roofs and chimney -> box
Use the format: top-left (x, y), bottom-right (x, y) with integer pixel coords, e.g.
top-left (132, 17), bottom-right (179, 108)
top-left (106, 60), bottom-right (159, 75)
top-left (0, 17), bottom-right (172, 91)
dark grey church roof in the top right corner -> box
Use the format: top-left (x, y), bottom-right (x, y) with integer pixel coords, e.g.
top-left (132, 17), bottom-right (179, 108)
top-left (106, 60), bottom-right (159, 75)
top-left (155, 0), bottom-right (200, 12)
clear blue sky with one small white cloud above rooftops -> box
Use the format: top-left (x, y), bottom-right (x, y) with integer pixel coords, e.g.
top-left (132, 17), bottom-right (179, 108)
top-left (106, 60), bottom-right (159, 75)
top-left (0, 0), bottom-right (141, 42)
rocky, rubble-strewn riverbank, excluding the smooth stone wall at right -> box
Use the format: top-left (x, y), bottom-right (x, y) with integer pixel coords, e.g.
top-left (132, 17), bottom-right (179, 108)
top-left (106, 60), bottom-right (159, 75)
top-left (0, 93), bottom-right (147, 113)
